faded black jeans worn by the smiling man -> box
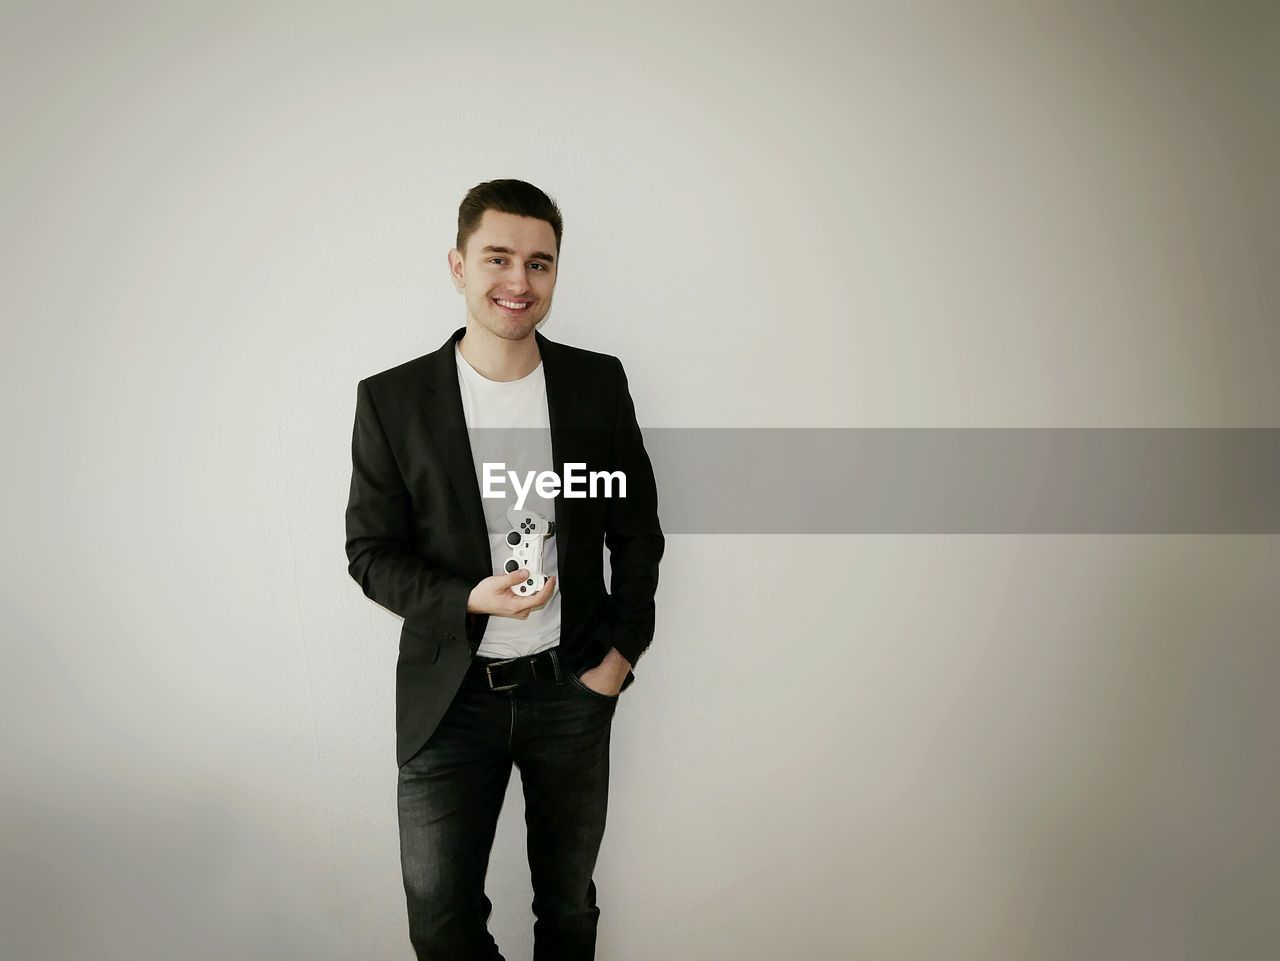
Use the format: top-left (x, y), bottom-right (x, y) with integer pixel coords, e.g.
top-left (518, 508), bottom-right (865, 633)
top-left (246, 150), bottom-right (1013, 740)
top-left (398, 651), bottom-right (618, 961)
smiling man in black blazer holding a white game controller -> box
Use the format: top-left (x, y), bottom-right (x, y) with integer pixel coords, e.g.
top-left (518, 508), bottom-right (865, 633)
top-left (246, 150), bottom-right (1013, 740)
top-left (347, 180), bottom-right (664, 961)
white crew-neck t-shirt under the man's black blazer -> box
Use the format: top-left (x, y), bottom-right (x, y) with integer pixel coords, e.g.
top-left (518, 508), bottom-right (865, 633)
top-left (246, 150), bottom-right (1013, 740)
top-left (453, 345), bottom-right (561, 658)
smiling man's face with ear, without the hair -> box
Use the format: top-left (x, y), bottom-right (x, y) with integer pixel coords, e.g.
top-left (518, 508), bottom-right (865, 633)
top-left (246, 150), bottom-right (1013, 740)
top-left (449, 210), bottom-right (559, 340)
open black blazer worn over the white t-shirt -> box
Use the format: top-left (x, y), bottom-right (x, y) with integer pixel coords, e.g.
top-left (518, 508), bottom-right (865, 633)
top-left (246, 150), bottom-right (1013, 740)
top-left (347, 328), bottom-right (664, 765)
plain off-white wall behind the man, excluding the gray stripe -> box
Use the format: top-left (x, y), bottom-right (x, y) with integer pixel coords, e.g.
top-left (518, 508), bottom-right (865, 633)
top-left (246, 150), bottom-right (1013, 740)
top-left (0, 3), bottom-right (1280, 961)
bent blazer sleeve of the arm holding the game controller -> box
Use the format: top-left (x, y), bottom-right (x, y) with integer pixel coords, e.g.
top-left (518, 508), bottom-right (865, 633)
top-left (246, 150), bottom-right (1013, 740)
top-left (347, 380), bottom-right (475, 639)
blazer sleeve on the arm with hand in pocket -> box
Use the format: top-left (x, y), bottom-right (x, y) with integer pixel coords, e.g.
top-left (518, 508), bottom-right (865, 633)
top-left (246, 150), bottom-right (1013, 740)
top-left (604, 357), bottom-right (666, 667)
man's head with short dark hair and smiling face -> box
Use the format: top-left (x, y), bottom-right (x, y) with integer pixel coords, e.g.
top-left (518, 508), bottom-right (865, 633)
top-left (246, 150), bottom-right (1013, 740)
top-left (449, 180), bottom-right (562, 340)
